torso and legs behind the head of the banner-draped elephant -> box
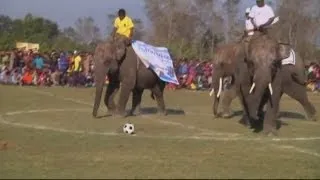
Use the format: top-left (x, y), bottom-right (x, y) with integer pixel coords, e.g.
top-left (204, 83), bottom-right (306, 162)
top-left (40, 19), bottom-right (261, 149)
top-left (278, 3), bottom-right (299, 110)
top-left (118, 47), bottom-right (166, 115)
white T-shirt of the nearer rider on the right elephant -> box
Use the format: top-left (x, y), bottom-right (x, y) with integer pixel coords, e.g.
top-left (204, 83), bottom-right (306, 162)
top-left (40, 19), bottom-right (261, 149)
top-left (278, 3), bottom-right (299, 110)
top-left (249, 4), bottom-right (274, 27)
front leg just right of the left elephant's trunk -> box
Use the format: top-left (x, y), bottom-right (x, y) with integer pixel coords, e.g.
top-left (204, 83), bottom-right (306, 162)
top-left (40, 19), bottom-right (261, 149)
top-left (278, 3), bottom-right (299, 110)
top-left (104, 74), bottom-right (120, 114)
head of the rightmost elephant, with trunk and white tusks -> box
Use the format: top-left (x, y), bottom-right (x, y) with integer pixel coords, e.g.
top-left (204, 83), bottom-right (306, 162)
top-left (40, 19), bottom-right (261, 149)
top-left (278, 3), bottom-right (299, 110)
top-left (246, 35), bottom-right (280, 119)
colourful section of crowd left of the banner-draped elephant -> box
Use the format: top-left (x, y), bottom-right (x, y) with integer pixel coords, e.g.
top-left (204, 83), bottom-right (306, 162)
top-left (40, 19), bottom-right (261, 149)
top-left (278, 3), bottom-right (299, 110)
top-left (0, 49), bottom-right (94, 87)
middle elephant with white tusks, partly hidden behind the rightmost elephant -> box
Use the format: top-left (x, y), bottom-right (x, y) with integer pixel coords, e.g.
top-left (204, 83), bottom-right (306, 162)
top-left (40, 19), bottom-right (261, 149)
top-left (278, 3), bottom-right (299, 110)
top-left (210, 37), bottom-right (263, 127)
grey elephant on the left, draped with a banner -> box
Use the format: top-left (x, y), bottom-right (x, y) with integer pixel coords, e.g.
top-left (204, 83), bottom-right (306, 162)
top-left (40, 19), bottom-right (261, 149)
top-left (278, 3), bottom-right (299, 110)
top-left (92, 34), bottom-right (166, 117)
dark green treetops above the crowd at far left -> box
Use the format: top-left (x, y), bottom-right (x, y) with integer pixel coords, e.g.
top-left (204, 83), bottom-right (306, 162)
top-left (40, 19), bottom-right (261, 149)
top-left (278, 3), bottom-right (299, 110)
top-left (0, 14), bottom-right (93, 52)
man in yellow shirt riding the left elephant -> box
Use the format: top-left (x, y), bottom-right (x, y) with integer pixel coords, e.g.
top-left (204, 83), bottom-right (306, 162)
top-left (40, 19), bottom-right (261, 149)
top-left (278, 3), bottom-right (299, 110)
top-left (112, 9), bottom-right (134, 39)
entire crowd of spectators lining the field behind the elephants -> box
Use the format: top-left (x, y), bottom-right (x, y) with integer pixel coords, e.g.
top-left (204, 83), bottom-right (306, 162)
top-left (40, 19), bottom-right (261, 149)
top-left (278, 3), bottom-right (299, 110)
top-left (0, 49), bottom-right (320, 91)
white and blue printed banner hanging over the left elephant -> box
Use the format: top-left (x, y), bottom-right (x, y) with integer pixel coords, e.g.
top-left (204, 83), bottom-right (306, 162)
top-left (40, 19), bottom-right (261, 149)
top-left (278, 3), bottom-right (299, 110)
top-left (132, 40), bottom-right (179, 85)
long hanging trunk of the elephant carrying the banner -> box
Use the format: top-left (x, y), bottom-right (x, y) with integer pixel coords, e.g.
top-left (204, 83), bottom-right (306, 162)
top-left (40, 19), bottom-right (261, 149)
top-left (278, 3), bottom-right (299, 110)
top-left (92, 65), bottom-right (109, 117)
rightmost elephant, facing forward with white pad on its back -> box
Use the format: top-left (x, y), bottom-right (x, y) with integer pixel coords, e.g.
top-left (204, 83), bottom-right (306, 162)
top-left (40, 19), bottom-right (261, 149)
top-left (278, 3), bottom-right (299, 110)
top-left (246, 33), bottom-right (316, 135)
